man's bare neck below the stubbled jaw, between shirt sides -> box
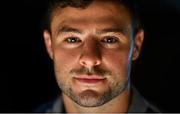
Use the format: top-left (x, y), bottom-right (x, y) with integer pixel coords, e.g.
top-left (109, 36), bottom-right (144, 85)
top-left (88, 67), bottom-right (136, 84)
top-left (63, 89), bottom-right (130, 113)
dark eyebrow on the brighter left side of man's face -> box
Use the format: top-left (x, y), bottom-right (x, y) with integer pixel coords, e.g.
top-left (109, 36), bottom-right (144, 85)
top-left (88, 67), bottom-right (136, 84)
top-left (58, 26), bottom-right (82, 34)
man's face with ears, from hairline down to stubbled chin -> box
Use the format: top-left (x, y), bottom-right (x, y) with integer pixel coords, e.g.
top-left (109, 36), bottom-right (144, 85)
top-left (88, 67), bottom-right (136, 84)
top-left (44, 2), bottom-right (143, 107)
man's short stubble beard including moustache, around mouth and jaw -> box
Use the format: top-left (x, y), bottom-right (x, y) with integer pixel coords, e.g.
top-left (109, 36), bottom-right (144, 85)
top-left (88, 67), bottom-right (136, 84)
top-left (56, 68), bottom-right (129, 107)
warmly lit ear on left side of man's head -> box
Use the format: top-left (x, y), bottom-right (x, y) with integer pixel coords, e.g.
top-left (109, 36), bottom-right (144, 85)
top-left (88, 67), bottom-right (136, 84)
top-left (43, 30), bottom-right (53, 59)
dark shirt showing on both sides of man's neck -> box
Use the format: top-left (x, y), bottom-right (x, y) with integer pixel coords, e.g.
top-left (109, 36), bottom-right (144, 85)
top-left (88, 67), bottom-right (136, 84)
top-left (35, 88), bottom-right (160, 113)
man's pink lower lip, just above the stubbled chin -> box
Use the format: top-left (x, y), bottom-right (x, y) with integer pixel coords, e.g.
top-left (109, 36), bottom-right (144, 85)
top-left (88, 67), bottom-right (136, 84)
top-left (75, 78), bottom-right (104, 84)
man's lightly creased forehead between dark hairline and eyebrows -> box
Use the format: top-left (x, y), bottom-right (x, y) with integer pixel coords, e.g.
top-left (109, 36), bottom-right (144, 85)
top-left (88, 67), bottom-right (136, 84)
top-left (51, 1), bottom-right (131, 33)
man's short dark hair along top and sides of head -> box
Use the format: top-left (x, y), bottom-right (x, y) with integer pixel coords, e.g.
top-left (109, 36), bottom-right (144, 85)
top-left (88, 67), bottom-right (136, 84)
top-left (43, 0), bottom-right (142, 34)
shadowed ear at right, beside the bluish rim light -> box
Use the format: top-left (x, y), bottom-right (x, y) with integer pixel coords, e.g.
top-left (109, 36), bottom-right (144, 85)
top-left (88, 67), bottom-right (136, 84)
top-left (133, 29), bottom-right (144, 60)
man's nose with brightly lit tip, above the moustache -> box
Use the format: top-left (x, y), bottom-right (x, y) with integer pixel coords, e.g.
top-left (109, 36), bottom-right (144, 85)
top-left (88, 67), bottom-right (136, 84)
top-left (79, 41), bottom-right (101, 68)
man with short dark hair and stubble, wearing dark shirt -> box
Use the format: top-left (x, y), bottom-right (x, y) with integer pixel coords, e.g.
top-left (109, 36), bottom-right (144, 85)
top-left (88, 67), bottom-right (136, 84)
top-left (37, 0), bottom-right (160, 113)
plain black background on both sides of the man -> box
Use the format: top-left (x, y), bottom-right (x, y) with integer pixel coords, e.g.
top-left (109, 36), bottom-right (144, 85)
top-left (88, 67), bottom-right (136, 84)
top-left (0, 0), bottom-right (180, 112)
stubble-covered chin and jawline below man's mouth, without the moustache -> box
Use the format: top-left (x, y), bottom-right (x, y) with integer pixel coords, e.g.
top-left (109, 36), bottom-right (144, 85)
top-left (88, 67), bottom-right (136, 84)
top-left (60, 77), bottom-right (129, 107)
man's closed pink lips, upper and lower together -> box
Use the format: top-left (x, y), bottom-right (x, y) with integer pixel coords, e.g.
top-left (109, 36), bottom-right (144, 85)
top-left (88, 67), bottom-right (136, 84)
top-left (74, 75), bottom-right (105, 84)
